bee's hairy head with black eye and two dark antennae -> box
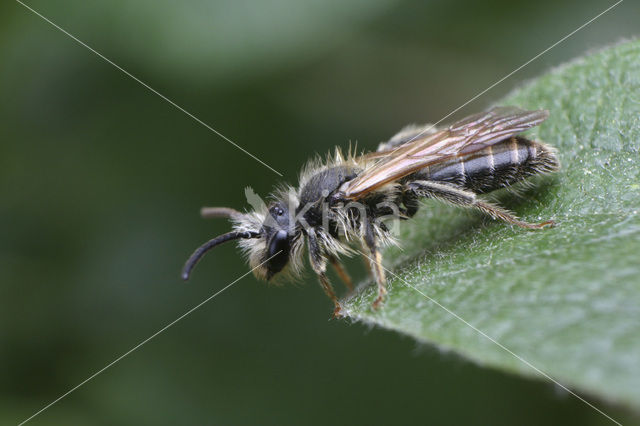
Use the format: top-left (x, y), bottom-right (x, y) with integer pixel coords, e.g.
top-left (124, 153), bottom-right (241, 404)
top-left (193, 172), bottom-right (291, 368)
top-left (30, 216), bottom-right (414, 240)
top-left (182, 196), bottom-right (302, 281)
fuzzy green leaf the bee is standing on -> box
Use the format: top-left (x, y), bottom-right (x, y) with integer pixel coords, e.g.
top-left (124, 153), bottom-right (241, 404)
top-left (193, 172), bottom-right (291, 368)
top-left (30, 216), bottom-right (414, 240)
top-left (345, 41), bottom-right (640, 407)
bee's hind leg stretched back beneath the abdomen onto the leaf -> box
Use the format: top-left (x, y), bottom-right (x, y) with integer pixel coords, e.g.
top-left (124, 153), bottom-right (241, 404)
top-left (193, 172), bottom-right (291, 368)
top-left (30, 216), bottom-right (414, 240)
top-left (406, 180), bottom-right (554, 229)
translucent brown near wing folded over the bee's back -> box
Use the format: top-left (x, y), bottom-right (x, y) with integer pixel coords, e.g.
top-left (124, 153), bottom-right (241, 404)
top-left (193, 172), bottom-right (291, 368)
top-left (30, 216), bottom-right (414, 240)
top-left (340, 107), bottom-right (549, 199)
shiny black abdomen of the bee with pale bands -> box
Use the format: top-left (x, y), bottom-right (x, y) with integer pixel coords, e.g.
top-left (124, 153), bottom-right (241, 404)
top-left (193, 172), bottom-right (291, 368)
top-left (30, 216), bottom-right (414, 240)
top-left (412, 136), bottom-right (559, 193)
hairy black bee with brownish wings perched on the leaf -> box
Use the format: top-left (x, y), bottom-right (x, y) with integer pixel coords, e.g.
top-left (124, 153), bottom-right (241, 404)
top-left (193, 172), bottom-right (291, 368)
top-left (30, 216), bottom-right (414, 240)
top-left (182, 107), bottom-right (560, 316)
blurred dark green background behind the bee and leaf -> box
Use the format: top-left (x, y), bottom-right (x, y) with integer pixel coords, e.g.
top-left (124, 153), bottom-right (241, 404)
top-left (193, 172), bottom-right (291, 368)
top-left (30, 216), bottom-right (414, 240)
top-left (0, 0), bottom-right (640, 425)
